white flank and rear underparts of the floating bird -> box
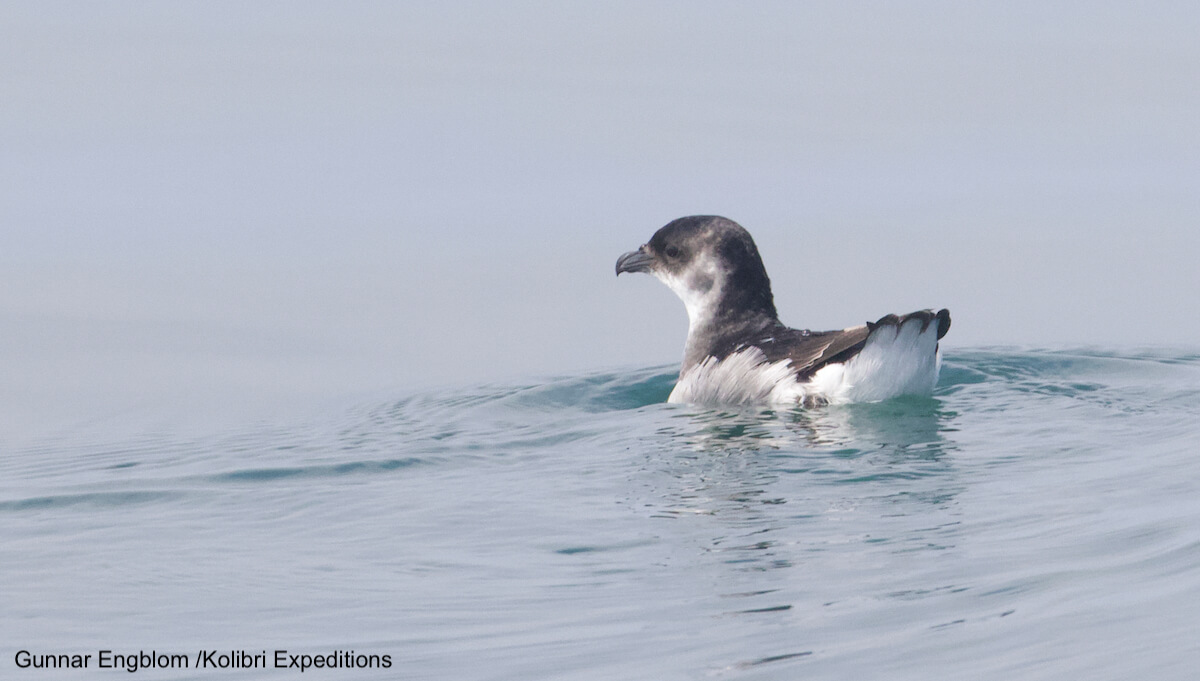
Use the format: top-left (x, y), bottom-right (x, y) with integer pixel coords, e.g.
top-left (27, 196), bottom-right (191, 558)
top-left (667, 316), bottom-right (942, 404)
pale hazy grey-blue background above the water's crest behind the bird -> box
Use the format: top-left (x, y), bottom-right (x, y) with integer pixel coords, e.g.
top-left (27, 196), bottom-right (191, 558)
top-left (0, 0), bottom-right (1200, 427)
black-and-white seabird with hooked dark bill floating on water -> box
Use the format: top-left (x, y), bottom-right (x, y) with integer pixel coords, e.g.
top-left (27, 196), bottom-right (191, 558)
top-left (617, 216), bottom-right (950, 406)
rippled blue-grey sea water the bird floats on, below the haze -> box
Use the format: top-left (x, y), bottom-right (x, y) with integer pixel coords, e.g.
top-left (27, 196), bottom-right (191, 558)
top-left (0, 349), bottom-right (1200, 681)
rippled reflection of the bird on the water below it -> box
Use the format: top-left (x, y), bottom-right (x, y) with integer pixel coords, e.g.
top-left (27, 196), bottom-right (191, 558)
top-left (642, 399), bottom-right (961, 667)
